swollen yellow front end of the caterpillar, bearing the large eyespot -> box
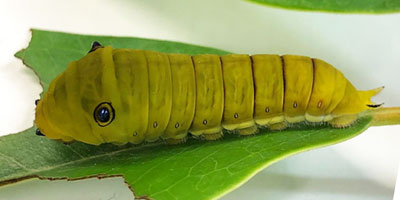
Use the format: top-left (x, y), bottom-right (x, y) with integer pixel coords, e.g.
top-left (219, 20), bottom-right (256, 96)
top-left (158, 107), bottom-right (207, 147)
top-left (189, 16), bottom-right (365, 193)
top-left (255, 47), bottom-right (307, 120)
top-left (35, 42), bottom-right (126, 144)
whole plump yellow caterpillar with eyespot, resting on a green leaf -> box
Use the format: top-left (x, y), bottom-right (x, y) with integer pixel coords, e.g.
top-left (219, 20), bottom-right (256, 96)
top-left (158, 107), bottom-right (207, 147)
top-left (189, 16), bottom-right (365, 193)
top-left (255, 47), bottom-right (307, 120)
top-left (35, 42), bottom-right (383, 145)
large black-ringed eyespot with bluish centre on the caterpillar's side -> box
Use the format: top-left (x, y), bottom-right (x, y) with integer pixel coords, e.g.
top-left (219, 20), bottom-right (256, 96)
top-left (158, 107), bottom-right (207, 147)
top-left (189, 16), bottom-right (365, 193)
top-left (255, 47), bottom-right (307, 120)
top-left (93, 102), bottom-right (115, 127)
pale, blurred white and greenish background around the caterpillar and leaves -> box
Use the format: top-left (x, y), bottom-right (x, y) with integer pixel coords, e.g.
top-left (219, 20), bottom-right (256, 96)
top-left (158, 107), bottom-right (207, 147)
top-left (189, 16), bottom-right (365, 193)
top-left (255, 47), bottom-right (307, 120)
top-left (0, 0), bottom-right (400, 200)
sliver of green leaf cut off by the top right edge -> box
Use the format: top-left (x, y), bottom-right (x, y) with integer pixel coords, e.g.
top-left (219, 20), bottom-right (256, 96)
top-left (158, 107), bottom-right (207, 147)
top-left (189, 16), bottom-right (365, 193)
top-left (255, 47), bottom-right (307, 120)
top-left (247, 0), bottom-right (400, 13)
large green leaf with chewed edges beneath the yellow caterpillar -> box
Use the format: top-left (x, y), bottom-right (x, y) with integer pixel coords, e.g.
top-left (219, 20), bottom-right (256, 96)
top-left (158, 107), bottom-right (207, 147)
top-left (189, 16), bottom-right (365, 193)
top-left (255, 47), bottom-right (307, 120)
top-left (0, 30), bottom-right (371, 199)
